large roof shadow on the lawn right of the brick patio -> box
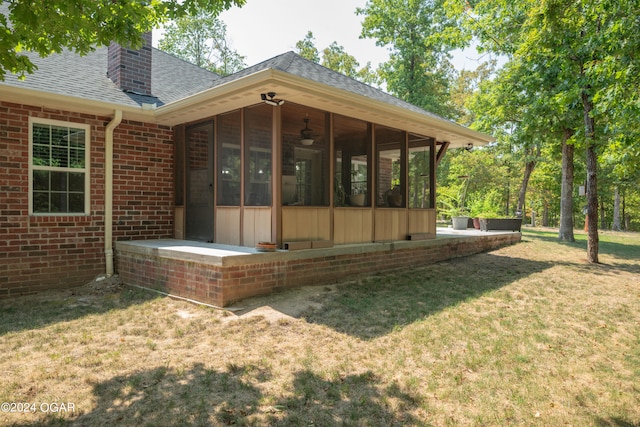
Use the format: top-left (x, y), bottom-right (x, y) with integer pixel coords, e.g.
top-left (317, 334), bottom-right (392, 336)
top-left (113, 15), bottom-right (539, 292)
top-left (299, 253), bottom-right (553, 339)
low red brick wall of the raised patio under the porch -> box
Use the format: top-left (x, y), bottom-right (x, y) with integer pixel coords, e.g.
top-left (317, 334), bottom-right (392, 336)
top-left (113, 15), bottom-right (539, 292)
top-left (117, 233), bottom-right (521, 307)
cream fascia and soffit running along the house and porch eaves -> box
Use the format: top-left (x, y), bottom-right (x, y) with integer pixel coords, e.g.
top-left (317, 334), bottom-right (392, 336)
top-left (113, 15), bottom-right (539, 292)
top-left (0, 68), bottom-right (495, 148)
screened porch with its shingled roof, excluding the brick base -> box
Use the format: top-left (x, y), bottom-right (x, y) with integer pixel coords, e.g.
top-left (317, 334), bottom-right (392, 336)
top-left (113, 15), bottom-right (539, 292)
top-left (164, 53), bottom-right (491, 250)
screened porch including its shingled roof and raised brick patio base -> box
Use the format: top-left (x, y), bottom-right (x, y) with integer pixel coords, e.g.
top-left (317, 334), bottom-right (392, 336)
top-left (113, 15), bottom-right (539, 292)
top-left (116, 52), bottom-right (504, 306)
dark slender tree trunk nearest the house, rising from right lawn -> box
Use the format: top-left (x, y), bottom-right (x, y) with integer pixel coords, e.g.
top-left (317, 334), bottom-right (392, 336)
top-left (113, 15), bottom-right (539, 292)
top-left (581, 90), bottom-right (599, 264)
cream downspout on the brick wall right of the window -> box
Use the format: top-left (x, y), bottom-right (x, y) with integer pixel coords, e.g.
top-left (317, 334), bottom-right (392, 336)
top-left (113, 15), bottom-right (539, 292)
top-left (104, 110), bottom-right (122, 277)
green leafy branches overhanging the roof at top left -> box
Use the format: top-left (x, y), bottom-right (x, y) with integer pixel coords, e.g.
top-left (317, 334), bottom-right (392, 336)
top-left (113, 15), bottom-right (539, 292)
top-left (0, 0), bottom-right (245, 80)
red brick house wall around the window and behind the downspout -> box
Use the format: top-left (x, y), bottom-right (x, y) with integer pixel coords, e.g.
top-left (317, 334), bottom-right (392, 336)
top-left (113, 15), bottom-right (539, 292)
top-left (0, 102), bottom-right (173, 297)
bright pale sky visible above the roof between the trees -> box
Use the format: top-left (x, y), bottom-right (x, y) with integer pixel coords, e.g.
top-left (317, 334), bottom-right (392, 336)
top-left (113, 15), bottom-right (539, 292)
top-left (154, 0), bottom-right (478, 69)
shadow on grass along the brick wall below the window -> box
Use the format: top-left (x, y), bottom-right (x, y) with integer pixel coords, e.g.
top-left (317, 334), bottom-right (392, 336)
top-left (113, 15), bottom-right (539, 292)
top-left (0, 287), bottom-right (159, 336)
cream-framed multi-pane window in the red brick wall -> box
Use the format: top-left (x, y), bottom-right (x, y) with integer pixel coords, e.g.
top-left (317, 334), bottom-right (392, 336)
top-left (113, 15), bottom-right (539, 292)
top-left (29, 117), bottom-right (91, 215)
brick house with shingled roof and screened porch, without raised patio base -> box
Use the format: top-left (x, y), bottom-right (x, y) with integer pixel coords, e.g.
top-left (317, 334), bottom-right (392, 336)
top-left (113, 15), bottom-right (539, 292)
top-left (0, 35), bottom-right (492, 297)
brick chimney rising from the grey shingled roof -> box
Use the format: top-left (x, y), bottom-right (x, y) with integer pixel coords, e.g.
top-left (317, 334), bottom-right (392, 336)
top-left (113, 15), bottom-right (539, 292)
top-left (107, 31), bottom-right (151, 95)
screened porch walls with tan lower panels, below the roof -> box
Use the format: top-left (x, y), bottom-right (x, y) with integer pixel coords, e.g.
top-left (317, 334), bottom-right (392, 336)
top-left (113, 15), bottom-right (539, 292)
top-left (176, 103), bottom-right (442, 249)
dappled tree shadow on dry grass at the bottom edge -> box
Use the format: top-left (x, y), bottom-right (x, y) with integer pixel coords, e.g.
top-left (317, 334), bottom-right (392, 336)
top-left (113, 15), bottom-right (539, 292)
top-left (16, 363), bottom-right (417, 426)
